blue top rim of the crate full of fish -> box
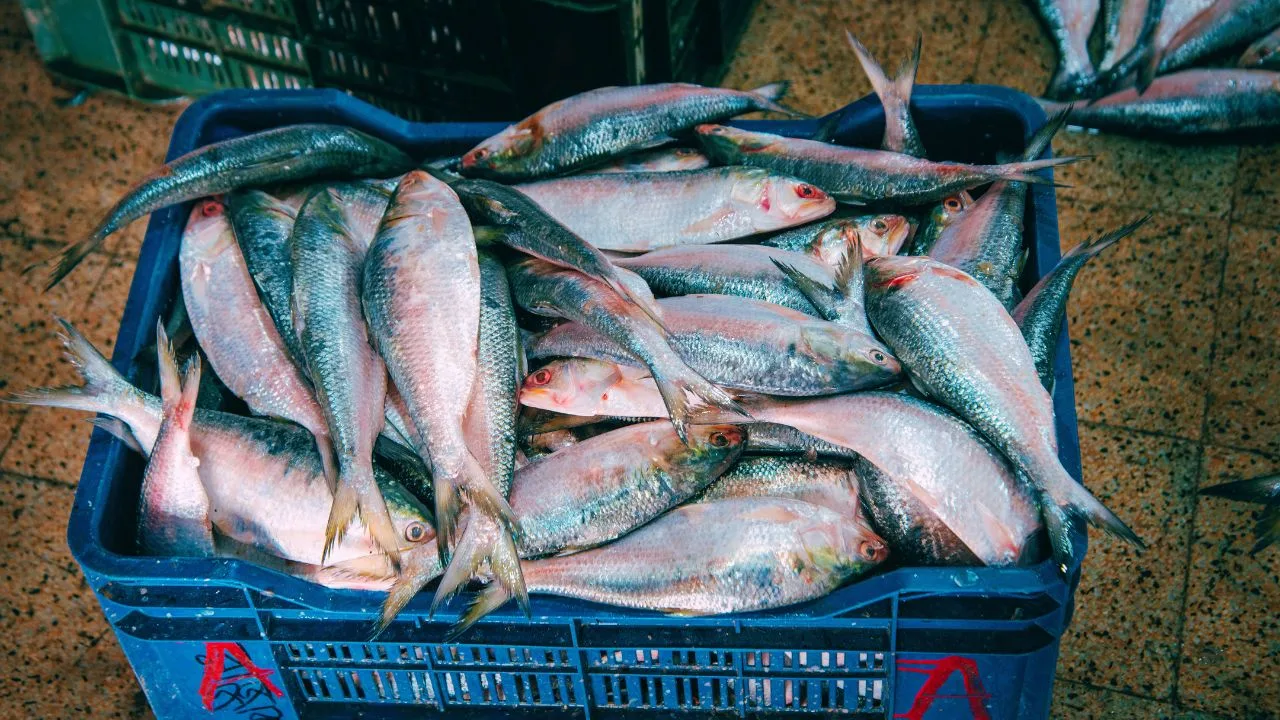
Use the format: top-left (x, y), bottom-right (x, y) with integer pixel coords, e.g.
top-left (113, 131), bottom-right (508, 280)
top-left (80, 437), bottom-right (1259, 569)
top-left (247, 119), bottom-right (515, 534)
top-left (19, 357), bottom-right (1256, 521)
top-left (67, 85), bottom-right (1087, 623)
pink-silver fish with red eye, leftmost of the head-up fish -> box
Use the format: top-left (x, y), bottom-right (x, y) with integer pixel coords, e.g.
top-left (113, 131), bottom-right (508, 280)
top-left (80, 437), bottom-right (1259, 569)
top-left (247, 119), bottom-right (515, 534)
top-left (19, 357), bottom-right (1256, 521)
top-left (178, 200), bottom-right (338, 482)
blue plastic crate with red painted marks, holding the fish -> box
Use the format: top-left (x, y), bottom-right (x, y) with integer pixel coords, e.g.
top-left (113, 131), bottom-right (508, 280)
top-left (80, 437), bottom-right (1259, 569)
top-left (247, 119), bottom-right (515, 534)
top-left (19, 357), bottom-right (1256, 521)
top-left (60, 86), bottom-right (1084, 720)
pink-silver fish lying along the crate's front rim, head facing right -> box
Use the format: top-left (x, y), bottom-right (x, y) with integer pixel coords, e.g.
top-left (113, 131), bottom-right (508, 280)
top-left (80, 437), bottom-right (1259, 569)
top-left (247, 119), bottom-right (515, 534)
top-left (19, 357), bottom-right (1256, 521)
top-left (448, 497), bottom-right (890, 641)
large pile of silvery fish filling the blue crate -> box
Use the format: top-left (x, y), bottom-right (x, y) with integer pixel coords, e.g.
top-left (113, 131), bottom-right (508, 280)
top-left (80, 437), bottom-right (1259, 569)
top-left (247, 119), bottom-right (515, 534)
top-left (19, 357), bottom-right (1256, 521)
top-left (9, 39), bottom-right (1157, 630)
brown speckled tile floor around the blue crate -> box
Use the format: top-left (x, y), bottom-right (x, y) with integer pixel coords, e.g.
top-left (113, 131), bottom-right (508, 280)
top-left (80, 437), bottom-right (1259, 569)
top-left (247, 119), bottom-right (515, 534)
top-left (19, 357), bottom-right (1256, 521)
top-left (0, 0), bottom-right (1280, 720)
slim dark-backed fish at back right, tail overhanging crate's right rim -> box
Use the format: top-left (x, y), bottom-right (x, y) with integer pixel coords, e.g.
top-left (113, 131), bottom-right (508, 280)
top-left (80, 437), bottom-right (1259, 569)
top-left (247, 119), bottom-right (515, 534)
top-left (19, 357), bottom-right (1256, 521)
top-left (695, 126), bottom-right (1076, 205)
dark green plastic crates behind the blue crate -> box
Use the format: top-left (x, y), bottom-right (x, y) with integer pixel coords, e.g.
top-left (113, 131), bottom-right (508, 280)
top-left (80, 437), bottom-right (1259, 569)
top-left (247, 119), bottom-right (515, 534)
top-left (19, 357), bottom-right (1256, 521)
top-left (22, 0), bottom-right (753, 120)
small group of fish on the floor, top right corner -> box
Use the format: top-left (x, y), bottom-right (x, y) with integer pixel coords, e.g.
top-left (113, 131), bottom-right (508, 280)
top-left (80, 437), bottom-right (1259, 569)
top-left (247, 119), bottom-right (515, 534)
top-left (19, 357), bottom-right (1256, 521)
top-left (1036, 0), bottom-right (1280, 136)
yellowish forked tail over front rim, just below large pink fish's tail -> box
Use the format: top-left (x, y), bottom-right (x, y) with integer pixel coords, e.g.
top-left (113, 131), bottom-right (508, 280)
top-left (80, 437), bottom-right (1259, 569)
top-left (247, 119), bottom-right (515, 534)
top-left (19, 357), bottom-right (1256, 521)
top-left (430, 515), bottom-right (530, 615)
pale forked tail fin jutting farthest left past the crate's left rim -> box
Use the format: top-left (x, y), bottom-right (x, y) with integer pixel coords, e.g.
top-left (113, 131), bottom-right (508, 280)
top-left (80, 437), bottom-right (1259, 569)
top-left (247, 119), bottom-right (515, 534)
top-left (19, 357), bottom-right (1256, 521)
top-left (0, 316), bottom-right (140, 415)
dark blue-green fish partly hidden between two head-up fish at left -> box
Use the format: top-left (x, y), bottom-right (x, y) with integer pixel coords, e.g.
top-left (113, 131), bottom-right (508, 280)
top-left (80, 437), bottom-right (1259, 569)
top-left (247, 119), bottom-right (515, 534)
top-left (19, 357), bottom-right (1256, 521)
top-left (227, 190), bottom-right (306, 370)
